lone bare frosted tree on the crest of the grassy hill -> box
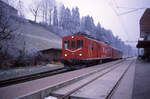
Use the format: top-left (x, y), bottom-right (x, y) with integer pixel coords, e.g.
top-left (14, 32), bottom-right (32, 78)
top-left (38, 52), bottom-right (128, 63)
top-left (29, 0), bottom-right (41, 22)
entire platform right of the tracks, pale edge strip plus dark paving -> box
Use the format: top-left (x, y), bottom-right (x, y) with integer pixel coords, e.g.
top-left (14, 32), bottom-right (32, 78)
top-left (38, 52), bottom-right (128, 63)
top-left (111, 59), bottom-right (150, 99)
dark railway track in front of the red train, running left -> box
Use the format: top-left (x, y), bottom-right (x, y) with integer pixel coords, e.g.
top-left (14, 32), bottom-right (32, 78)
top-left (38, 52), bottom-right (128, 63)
top-left (0, 68), bottom-right (68, 87)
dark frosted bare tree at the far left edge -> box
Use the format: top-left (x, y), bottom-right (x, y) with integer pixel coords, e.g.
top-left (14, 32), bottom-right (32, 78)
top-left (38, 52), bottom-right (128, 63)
top-left (0, 6), bottom-right (16, 68)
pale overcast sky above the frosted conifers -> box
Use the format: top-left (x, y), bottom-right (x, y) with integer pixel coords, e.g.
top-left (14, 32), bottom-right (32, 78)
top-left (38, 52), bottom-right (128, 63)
top-left (24, 0), bottom-right (150, 45)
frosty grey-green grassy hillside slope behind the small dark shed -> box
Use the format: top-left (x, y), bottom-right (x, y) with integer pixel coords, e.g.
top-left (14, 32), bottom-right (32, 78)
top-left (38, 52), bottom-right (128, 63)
top-left (17, 21), bottom-right (62, 50)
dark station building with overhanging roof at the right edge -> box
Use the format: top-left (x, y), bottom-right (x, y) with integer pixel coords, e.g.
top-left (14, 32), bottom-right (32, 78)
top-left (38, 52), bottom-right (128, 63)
top-left (137, 8), bottom-right (150, 59)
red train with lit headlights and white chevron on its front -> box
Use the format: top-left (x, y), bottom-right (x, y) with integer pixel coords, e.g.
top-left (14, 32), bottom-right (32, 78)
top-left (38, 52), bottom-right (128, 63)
top-left (62, 34), bottom-right (123, 65)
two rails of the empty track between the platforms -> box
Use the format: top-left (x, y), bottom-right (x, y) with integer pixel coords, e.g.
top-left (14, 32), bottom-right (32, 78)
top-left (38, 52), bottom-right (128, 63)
top-left (48, 58), bottom-right (133, 99)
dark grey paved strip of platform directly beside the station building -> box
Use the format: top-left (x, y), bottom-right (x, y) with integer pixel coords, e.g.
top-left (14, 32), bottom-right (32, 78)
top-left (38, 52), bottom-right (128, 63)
top-left (132, 60), bottom-right (150, 99)
